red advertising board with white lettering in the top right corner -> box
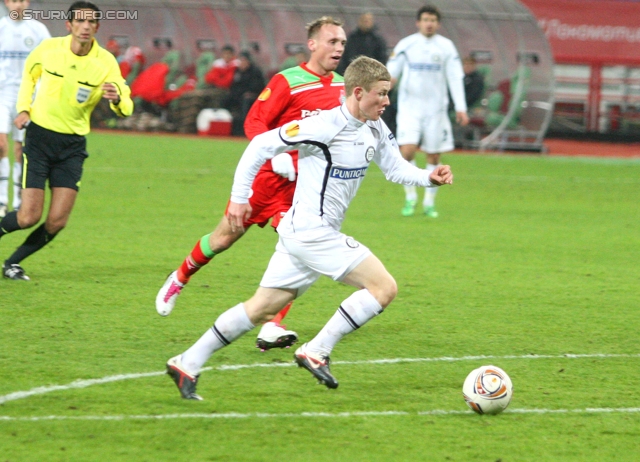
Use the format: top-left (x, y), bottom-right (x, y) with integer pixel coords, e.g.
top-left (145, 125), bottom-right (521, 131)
top-left (521, 0), bottom-right (640, 64)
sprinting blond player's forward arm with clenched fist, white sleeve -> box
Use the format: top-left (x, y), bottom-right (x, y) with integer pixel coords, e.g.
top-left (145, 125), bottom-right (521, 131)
top-left (373, 121), bottom-right (453, 187)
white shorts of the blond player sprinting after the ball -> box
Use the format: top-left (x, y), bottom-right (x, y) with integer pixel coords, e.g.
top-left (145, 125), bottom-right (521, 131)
top-left (260, 227), bottom-right (371, 296)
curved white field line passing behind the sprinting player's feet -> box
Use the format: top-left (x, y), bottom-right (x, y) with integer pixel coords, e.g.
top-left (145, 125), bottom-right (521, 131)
top-left (0, 354), bottom-right (640, 404)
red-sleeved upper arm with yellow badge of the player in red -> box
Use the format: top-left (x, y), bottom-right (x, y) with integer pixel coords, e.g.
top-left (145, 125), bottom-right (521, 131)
top-left (244, 74), bottom-right (291, 140)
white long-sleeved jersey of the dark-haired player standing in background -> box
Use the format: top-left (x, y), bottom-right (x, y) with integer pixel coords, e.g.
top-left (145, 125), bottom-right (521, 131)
top-left (387, 33), bottom-right (467, 116)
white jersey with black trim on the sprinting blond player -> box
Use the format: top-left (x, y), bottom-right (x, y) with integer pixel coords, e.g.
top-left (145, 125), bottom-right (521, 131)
top-left (231, 104), bottom-right (432, 234)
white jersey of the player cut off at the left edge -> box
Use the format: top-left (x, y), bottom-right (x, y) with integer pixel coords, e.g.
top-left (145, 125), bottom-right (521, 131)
top-left (0, 16), bottom-right (51, 104)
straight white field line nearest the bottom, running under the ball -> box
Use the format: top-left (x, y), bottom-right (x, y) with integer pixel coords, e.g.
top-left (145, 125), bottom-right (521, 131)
top-left (0, 407), bottom-right (640, 422)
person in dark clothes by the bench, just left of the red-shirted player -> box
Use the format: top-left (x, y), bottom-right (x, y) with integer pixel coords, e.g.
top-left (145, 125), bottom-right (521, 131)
top-left (223, 51), bottom-right (266, 136)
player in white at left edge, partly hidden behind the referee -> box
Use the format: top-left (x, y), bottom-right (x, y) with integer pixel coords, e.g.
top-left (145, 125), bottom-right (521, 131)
top-left (0, 0), bottom-right (51, 218)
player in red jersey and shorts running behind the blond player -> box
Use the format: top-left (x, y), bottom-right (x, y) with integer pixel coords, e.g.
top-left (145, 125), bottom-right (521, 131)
top-left (156, 16), bottom-right (346, 350)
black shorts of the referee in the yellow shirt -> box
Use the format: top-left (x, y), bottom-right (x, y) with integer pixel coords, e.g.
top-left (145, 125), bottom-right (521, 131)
top-left (22, 122), bottom-right (89, 191)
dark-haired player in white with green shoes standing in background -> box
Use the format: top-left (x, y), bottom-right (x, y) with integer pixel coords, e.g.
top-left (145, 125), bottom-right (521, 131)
top-left (387, 6), bottom-right (469, 218)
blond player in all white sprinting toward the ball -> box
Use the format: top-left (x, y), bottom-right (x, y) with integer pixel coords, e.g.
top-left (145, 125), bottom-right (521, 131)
top-left (167, 56), bottom-right (453, 399)
